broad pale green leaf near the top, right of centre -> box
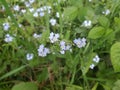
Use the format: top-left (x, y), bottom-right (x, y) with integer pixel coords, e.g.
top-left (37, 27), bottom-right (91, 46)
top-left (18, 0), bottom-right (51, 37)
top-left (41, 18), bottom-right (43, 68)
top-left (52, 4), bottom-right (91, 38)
top-left (63, 6), bottom-right (78, 21)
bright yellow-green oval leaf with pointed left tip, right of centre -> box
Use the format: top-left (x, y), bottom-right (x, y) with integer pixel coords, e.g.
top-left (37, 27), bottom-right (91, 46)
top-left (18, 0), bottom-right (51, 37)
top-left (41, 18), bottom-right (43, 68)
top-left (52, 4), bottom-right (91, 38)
top-left (88, 27), bottom-right (105, 39)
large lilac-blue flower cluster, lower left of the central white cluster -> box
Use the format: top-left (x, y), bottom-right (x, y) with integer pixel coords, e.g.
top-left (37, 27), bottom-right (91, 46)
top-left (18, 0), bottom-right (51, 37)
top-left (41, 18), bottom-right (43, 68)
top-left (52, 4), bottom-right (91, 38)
top-left (38, 44), bottom-right (50, 57)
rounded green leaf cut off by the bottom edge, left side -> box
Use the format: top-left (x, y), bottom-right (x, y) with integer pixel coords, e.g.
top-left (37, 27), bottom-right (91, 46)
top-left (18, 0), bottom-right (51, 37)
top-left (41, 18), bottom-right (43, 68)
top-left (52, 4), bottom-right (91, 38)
top-left (12, 82), bottom-right (38, 90)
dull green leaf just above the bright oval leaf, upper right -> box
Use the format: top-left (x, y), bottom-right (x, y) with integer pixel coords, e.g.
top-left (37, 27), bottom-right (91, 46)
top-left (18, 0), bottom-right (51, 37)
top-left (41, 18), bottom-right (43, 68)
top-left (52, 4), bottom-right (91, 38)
top-left (98, 16), bottom-right (110, 28)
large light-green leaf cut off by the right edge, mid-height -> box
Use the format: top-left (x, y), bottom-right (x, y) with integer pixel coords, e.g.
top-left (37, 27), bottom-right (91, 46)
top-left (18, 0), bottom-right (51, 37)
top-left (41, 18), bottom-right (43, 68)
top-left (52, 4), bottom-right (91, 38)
top-left (110, 42), bottom-right (120, 72)
